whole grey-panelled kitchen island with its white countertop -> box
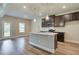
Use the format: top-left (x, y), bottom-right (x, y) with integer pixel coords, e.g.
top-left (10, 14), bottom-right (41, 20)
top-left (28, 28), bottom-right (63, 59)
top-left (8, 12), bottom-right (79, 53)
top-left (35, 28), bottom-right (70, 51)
top-left (29, 32), bottom-right (57, 53)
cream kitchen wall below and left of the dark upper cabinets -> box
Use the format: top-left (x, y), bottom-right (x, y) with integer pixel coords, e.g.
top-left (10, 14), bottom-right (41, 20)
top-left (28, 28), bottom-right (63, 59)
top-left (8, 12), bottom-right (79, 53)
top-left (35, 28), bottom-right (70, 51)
top-left (32, 19), bottom-right (79, 43)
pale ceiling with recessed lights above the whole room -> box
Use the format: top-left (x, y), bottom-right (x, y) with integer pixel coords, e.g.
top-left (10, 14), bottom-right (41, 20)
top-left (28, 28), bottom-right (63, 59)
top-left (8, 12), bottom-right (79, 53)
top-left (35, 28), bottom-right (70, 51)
top-left (1, 3), bottom-right (79, 19)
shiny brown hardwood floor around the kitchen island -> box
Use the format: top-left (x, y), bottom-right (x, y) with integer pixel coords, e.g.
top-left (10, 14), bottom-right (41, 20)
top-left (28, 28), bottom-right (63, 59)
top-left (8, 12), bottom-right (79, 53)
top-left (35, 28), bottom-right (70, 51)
top-left (0, 37), bottom-right (79, 55)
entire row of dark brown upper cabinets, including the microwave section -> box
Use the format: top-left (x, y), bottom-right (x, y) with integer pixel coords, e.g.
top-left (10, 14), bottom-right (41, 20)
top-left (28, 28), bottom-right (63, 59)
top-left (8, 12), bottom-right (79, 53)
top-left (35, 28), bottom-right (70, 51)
top-left (42, 12), bottom-right (79, 27)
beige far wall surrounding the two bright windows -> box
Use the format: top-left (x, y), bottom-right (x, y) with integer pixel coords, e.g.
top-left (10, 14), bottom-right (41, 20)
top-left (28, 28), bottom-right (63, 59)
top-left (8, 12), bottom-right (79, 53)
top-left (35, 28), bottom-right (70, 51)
top-left (0, 16), bottom-right (31, 37)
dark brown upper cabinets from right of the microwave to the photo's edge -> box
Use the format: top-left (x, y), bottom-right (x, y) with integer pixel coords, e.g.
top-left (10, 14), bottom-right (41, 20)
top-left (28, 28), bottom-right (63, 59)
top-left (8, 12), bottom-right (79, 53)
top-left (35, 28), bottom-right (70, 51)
top-left (54, 12), bottom-right (79, 27)
